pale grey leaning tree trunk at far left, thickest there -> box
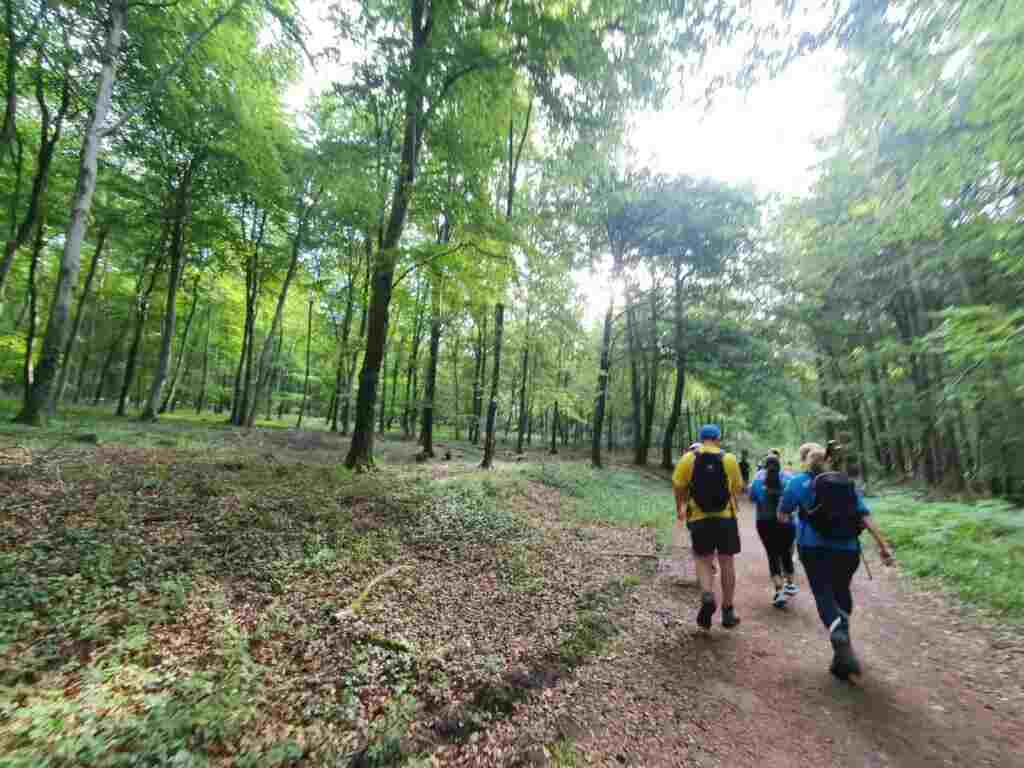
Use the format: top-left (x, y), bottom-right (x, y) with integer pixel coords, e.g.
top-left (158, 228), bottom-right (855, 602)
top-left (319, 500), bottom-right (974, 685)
top-left (18, 0), bottom-right (128, 425)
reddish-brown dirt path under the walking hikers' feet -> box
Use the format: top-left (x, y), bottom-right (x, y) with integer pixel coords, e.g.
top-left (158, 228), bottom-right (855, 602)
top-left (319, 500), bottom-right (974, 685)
top-left (528, 504), bottom-right (1024, 768)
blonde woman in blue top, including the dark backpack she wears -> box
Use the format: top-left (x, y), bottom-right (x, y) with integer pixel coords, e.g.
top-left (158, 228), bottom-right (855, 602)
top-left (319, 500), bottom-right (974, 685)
top-left (778, 442), bottom-right (892, 681)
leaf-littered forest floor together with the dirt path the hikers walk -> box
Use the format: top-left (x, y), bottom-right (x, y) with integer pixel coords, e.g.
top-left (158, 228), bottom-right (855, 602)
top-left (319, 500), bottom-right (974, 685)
top-left (0, 417), bottom-right (1024, 768)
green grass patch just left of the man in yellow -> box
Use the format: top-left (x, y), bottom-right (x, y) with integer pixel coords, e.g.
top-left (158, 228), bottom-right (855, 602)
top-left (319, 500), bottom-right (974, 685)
top-left (525, 463), bottom-right (675, 545)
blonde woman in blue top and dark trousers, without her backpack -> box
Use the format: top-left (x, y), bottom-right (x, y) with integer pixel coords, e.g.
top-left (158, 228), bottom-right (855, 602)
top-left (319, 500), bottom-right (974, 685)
top-left (778, 443), bottom-right (892, 680)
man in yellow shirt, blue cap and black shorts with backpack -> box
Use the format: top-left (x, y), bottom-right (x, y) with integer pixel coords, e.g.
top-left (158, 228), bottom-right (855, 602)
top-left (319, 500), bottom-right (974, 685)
top-left (672, 424), bottom-right (743, 630)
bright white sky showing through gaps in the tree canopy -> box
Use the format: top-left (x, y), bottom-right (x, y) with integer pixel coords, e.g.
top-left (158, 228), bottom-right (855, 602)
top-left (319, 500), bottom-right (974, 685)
top-left (288, 0), bottom-right (843, 319)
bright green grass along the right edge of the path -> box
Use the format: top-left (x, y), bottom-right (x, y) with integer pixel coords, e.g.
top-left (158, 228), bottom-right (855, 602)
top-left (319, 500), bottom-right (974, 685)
top-left (871, 494), bottom-right (1024, 623)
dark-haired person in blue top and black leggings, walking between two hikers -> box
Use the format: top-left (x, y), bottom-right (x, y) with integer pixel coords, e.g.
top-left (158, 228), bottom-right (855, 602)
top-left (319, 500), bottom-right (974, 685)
top-left (751, 454), bottom-right (800, 608)
